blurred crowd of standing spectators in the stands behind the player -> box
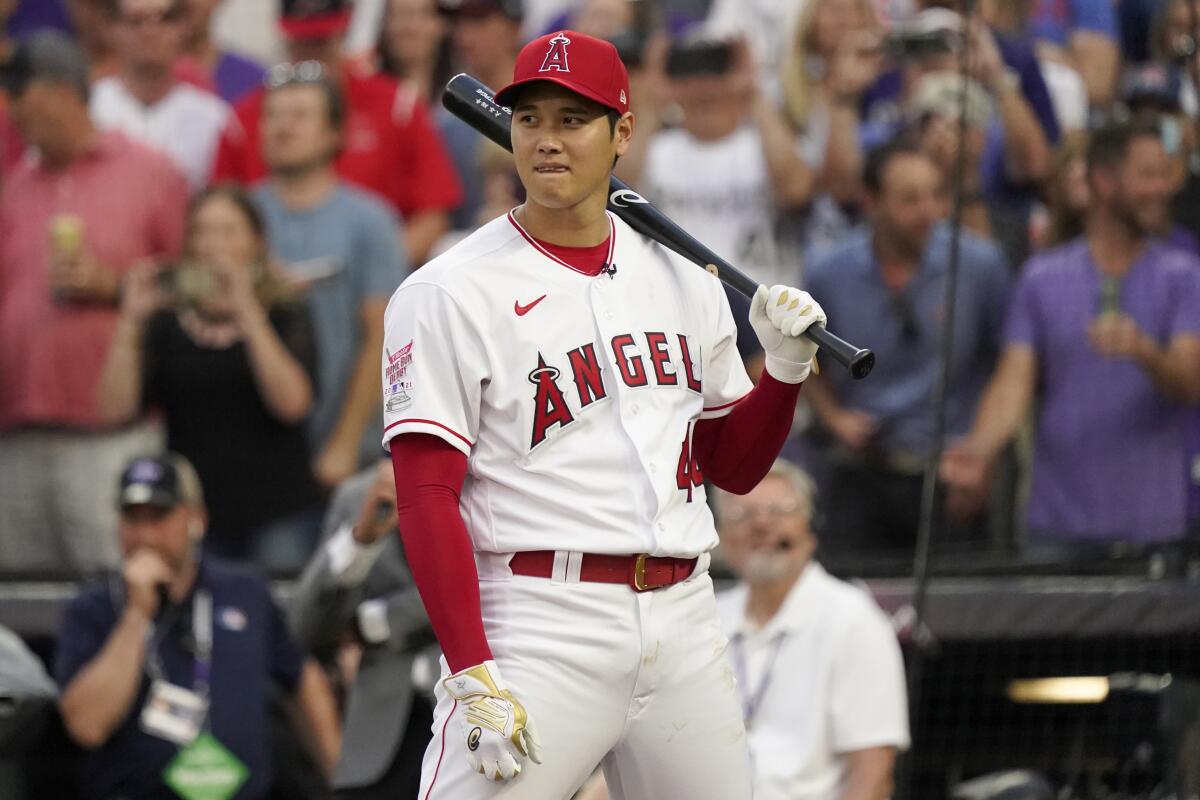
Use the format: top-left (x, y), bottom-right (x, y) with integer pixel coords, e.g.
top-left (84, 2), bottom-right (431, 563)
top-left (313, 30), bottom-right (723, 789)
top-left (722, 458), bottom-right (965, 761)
top-left (0, 0), bottom-right (1200, 582)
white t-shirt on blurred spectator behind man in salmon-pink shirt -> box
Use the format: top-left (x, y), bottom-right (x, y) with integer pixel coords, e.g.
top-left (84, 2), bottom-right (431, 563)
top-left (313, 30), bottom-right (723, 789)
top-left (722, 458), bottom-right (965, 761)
top-left (90, 76), bottom-right (230, 191)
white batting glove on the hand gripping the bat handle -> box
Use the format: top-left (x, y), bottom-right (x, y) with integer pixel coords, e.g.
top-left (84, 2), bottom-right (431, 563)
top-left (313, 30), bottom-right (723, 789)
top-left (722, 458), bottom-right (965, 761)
top-left (750, 285), bottom-right (826, 384)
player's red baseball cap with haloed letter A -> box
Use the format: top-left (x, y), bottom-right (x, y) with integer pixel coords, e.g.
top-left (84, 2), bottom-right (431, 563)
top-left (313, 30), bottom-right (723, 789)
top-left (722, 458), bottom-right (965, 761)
top-left (496, 30), bottom-right (629, 114)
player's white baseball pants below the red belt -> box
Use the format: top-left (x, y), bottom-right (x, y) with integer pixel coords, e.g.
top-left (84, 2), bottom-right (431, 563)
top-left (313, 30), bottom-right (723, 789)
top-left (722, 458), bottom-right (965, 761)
top-left (419, 558), bottom-right (751, 800)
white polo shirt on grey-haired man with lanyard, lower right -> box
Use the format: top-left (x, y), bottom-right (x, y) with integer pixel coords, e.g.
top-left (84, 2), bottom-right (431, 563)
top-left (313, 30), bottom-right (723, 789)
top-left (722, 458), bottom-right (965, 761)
top-left (716, 563), bottom-right (908, 800)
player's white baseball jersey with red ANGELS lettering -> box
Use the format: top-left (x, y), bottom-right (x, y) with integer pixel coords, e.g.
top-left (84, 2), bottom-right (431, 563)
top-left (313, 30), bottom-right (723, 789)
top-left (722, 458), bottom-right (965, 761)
top-left (383, 213), bottom-right (751, 557)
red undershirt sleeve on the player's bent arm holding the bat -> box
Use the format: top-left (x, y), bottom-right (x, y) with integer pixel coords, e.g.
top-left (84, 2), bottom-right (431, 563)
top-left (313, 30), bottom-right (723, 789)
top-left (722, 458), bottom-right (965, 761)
top-left (691, 371), bottom-right (800, 494)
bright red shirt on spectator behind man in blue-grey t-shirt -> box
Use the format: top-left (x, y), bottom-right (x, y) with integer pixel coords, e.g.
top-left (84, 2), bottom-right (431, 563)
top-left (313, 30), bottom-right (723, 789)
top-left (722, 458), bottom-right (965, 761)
top-left (212, 71), bottom-right (462, 217)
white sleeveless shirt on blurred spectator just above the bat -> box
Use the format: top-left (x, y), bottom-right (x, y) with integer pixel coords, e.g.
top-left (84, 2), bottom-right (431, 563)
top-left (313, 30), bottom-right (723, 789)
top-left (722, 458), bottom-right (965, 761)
top-left (640, 125), bottom-right (800, 287)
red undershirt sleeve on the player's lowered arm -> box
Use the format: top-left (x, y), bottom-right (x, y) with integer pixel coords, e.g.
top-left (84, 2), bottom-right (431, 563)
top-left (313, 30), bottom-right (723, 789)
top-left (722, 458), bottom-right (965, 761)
top-left (391, 433), bottom-right (492, 672)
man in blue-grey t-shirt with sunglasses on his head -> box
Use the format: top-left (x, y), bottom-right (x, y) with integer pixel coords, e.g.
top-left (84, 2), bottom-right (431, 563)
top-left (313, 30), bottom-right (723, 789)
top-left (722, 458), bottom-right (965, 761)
top-left (254, 71), bottom-right (406, 489)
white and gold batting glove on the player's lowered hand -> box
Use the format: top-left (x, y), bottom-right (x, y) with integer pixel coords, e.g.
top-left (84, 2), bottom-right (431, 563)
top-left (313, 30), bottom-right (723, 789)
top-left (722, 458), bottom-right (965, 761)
top-left (442, 661), bottom-right (541, 781)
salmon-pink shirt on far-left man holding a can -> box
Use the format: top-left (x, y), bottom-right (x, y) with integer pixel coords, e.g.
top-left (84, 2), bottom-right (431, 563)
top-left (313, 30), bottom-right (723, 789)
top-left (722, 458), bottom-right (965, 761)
top-left (0, 132), bottom-right (188, 431)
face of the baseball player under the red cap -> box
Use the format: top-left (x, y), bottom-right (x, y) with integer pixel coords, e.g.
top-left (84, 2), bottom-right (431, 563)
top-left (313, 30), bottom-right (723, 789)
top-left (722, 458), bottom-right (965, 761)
top-left (512, 83), bottom-right (634, 209)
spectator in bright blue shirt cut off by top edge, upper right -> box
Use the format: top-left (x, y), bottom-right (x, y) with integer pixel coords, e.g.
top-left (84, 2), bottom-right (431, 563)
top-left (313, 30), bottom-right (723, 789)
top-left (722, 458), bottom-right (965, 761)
top-left (1031, 0), bottom-right (1121, 109)
